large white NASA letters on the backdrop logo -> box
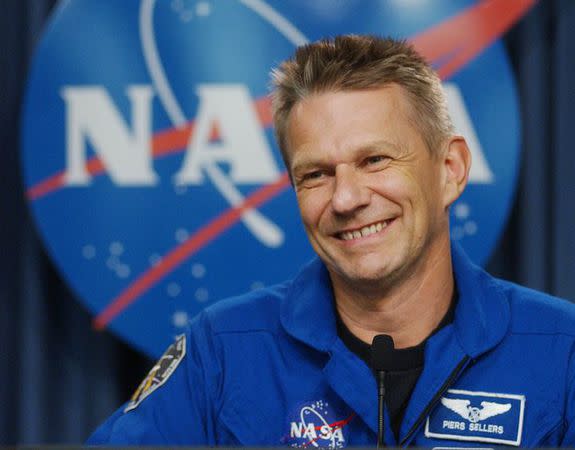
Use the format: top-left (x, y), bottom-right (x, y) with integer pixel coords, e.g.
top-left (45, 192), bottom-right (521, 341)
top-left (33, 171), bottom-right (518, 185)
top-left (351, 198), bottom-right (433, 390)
top-left (61, 83), bottom-right (494, 190)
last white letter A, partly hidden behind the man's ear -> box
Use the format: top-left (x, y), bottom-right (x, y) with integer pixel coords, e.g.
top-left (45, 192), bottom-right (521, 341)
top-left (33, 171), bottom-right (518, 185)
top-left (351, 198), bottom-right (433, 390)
top-left (443, 83), bottom-right (495, 184)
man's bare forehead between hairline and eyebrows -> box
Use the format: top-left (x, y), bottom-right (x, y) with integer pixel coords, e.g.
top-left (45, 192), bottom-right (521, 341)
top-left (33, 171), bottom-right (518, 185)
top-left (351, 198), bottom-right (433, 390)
top-left (286, 84), bottom-right (419, 167)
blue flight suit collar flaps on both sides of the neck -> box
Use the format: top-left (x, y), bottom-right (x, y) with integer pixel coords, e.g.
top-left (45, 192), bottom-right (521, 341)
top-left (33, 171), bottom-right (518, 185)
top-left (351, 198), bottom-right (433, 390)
top-left (281, 243), bottom-right (510, 358)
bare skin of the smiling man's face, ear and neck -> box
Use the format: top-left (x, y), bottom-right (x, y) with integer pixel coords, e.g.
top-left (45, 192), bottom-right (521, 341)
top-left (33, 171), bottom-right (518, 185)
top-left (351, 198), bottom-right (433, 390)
top-left (284, 82), bottom-right (470, 347)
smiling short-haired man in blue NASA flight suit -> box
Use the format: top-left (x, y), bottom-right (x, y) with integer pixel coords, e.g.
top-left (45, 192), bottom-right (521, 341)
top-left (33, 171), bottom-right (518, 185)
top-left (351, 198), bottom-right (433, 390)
top-left (90, 36), bottom-right (575, 447)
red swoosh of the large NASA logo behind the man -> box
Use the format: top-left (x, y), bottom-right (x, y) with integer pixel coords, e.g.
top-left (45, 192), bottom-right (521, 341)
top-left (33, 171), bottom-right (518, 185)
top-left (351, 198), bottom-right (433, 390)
top-left (22, 0), bottom-right (536, 329)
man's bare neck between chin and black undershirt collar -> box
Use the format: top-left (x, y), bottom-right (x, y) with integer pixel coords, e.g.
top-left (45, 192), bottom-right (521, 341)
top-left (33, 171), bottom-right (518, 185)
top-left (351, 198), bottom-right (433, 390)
top-left (332, 232), bottom-right (454, 348)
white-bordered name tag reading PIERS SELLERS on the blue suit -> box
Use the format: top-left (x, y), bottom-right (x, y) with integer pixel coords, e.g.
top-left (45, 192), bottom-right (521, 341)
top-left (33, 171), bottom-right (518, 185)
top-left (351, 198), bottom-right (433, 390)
top-left (425, 389), bottom-right (525, 446)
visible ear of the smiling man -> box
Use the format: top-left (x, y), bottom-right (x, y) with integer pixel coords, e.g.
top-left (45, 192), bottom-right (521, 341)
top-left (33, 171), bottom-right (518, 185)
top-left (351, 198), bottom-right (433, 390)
top-left (443, 136), bottom-right (471, 209)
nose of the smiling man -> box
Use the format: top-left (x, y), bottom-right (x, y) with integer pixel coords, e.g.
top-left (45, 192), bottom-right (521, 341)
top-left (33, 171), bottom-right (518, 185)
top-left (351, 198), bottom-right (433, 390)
top-left (331, 164), bottom-right (370, 215)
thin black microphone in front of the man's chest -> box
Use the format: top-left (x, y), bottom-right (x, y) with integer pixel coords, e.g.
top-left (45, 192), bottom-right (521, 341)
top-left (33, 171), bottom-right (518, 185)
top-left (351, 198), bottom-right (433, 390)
top-left (371, 334), bottom-right (394, 448)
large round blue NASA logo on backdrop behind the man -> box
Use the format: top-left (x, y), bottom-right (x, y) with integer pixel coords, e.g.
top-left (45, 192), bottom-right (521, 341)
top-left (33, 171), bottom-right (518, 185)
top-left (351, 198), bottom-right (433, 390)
top-left (21, 0), bottom-right (533, 356)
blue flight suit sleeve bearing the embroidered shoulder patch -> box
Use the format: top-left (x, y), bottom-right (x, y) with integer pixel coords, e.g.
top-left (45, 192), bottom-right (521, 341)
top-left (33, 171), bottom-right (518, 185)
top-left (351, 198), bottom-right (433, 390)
top-left (87, 313), bottom-right (219, 446)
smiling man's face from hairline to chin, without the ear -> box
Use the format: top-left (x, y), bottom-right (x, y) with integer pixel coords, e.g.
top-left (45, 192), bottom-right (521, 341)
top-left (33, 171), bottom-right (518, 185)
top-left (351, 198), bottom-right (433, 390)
top-left (287, 84), bottom-right (449, 292)
